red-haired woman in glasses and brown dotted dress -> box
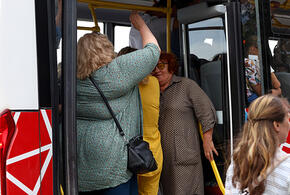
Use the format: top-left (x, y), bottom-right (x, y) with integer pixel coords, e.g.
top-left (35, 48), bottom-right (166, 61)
top-left (152, 52), bottom-right (217, 195)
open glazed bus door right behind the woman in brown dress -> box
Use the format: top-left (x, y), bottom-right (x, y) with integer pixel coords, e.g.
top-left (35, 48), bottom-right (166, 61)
top-left (177, 0), bottom-right (244, 191)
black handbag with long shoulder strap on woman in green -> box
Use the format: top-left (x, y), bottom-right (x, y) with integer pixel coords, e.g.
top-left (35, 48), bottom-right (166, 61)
top-left (89, 76), bottom-right (157, 174)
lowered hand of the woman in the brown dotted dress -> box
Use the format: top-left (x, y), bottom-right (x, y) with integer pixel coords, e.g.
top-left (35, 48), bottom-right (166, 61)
top-left (203, 129), bottom-right (218, 161)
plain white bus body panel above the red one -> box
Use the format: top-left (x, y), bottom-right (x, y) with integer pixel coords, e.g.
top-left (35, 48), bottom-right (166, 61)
top-left (0, 0), bottom-right (38, 111)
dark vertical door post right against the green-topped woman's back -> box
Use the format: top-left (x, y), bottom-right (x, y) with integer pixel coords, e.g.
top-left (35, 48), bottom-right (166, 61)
top-left (62, 0), bottom-right (78, 195)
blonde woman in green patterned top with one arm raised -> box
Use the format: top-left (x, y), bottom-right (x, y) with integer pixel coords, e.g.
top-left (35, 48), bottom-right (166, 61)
top-left (77, 12), bottom-right (160, 195)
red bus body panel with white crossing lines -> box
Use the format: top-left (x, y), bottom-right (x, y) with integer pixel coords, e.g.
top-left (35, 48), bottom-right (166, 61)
top-left (6, 109), bottom-right (53, 195)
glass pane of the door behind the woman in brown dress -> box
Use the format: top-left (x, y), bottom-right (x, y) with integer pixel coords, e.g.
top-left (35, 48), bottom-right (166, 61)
top-left (188, 18), bottom-right (227, 119)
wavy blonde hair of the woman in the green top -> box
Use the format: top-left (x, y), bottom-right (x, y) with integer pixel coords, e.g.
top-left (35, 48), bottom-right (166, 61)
top-left (77, 33), bottom-right (115, 80)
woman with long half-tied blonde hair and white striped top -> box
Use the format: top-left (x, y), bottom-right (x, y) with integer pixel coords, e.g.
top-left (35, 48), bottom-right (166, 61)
top-left (226, 95), bottom-right (290, 195)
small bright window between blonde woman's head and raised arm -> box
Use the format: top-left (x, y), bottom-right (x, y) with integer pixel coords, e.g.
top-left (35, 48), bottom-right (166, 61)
top-left (114, 25), bottom-right (131, 53)
